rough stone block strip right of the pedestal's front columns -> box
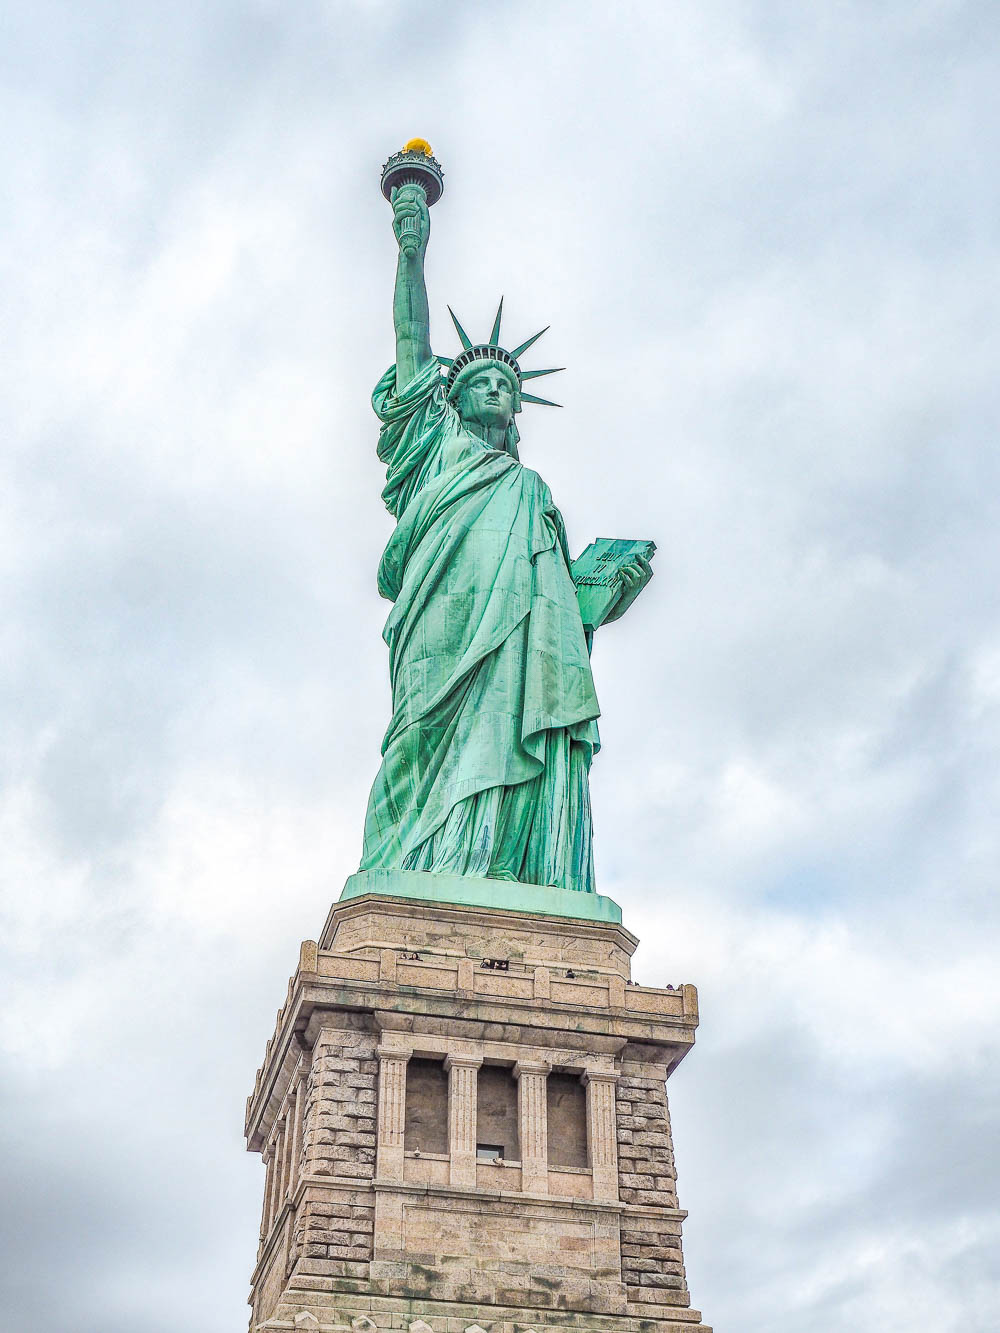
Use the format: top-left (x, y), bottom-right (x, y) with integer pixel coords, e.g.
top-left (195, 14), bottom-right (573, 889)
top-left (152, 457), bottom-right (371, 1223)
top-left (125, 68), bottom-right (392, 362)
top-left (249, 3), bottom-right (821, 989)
top-left (617, 1066), bottom-right (687, 1304)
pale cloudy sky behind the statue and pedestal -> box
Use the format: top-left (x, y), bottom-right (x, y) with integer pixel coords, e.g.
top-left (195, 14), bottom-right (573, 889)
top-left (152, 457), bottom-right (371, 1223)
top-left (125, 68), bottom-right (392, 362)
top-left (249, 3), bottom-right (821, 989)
top-left (0, 0), bottom-right (1000, 1333)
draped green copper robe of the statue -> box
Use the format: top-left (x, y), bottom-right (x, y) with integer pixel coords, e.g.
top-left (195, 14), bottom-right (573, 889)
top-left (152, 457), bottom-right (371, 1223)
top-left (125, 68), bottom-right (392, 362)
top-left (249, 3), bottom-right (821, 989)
top-left (361, 364), bottom-right (600, 893)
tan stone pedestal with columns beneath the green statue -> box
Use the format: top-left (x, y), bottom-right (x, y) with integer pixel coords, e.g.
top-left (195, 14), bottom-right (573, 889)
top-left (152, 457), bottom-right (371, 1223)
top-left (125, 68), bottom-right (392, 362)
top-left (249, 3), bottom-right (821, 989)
top-left (247, 873), bottom-right (711, 1333)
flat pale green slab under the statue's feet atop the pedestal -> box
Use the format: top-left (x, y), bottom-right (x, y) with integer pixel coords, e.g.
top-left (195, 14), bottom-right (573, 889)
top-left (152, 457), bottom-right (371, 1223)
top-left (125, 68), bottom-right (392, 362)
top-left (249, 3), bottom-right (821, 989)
top-left (340, 870), bottom-right (621, 925)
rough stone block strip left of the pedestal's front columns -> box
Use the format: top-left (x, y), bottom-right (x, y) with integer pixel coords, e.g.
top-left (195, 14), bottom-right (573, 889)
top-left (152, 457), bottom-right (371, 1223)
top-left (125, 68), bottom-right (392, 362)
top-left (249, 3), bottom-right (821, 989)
top-left (292, 1028), bottom-right (379, 1277)
